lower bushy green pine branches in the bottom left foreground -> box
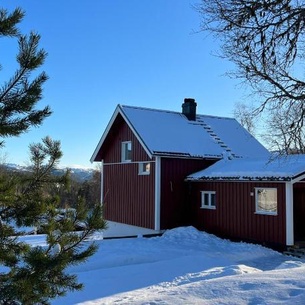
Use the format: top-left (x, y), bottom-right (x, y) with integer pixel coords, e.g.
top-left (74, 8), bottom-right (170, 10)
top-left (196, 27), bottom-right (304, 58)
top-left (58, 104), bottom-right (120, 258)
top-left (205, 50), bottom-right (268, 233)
top-left (0, 137), bottom-right (105, 305)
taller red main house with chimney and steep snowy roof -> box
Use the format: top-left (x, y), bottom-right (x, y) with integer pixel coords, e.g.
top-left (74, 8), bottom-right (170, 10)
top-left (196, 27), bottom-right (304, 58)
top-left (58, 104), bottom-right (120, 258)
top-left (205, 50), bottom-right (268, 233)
top-left (91, 99), bottom-right (288, 236)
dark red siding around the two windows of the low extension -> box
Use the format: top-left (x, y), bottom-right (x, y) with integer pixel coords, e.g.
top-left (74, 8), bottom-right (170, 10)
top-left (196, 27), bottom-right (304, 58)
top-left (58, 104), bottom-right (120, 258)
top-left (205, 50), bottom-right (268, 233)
top-left (190, 182), bottom-right (286, 245)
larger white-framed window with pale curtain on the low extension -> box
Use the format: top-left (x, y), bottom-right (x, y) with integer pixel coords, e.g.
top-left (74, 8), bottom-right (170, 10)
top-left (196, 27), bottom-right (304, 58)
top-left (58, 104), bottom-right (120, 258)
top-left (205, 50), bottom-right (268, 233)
top-left (255, 187), bottom-right (277, 215)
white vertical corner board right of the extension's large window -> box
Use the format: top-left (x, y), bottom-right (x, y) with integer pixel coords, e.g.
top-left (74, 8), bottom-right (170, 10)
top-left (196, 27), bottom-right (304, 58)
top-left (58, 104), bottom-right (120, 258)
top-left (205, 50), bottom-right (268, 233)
top-left (285, 181), bottom-right (294, 246)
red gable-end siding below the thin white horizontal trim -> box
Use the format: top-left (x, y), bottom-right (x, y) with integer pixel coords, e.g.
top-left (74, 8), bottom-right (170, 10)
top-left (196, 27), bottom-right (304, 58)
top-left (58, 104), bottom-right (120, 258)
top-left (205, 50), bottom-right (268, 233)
top-left (103, 163), bottom-right (154, 229)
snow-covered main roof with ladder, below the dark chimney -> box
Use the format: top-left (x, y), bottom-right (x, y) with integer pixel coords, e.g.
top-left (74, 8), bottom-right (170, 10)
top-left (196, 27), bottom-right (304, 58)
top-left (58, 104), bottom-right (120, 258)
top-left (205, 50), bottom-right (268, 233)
top-left (120, 106), bottom-right (268, 158)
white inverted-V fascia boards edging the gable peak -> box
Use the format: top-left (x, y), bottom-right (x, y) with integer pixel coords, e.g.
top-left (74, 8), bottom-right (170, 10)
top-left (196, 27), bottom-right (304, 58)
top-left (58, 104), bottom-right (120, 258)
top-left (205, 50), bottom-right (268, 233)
top-left (90, 105), bottom-right (152, 162)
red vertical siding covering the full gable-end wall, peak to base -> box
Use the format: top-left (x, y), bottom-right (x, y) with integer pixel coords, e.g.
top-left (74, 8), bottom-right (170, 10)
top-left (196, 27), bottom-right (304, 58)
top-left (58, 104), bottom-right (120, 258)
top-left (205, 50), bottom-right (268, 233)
top-left (101, 115), bottom-right (155, 229)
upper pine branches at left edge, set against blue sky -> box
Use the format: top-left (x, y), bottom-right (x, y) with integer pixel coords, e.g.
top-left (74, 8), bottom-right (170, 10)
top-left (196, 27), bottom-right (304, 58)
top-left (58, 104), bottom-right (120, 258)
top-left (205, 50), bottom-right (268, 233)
top-left (0, 8), bottom-right (51, 145)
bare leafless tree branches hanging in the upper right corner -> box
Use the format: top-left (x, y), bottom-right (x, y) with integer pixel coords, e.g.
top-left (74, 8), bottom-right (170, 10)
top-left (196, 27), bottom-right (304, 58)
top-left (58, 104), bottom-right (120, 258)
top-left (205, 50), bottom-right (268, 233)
top-left (196, 0), bottom-right (305, 150)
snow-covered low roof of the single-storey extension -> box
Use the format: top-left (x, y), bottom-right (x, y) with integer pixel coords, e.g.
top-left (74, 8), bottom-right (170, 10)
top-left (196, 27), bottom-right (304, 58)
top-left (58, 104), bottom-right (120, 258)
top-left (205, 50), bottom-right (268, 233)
top-left (187, 154), bottom-right (305, 181)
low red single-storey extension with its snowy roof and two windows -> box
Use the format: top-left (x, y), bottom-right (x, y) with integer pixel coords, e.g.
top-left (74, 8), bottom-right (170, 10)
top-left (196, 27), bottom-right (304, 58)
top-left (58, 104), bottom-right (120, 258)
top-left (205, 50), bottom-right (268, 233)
top-left (187, 155), bottom-right (305, 246)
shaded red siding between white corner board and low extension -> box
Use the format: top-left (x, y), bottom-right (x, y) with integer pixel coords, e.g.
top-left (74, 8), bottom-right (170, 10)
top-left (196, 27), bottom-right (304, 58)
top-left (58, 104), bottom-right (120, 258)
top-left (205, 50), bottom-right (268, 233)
top-left (160, 158), bottom-right (215, 229)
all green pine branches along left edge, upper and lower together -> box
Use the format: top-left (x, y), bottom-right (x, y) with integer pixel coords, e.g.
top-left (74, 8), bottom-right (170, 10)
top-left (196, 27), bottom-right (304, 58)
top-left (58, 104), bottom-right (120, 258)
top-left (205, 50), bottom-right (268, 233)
top-left (0, 5), bottom-right (105, 305)
